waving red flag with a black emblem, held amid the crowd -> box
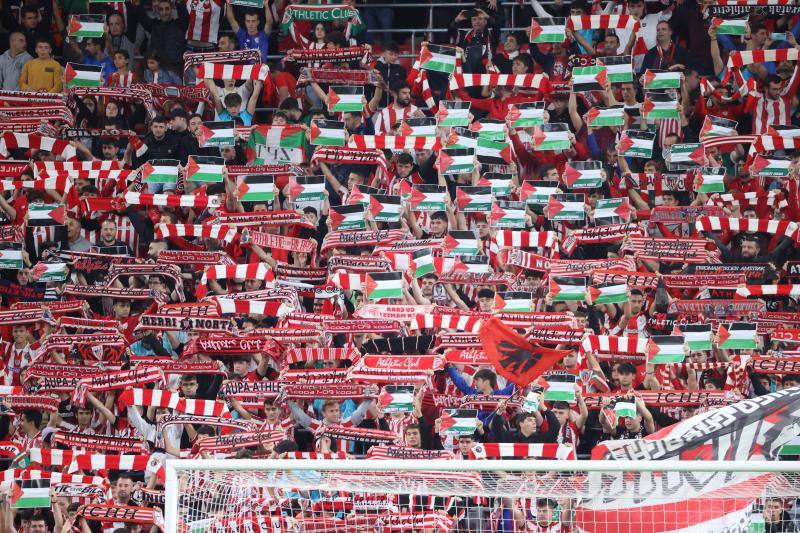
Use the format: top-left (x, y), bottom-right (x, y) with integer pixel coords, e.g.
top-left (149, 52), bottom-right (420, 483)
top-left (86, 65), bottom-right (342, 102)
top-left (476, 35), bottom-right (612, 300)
top-left (478, 318), bottom-right (570, 387)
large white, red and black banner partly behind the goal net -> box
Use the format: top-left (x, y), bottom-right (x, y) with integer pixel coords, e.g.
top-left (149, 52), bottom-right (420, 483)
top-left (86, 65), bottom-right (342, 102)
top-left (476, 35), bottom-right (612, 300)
top-left (576, 387), bottom-right (800, 533)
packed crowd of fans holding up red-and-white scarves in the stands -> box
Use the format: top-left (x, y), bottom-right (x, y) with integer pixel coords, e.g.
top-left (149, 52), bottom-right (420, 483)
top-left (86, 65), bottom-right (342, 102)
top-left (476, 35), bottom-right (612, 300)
top-left (0, 0), bottom-right (800, 533)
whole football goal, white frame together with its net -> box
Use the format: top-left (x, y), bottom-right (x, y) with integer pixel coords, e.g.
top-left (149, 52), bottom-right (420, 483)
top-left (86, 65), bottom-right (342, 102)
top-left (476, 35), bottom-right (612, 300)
top-left (165, 459), bottom-right (800, 533)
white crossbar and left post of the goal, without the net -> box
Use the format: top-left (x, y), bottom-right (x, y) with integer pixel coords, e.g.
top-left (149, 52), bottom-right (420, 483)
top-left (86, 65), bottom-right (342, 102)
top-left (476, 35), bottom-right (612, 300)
top-left (164, 459), bottom-right (800, 533)
